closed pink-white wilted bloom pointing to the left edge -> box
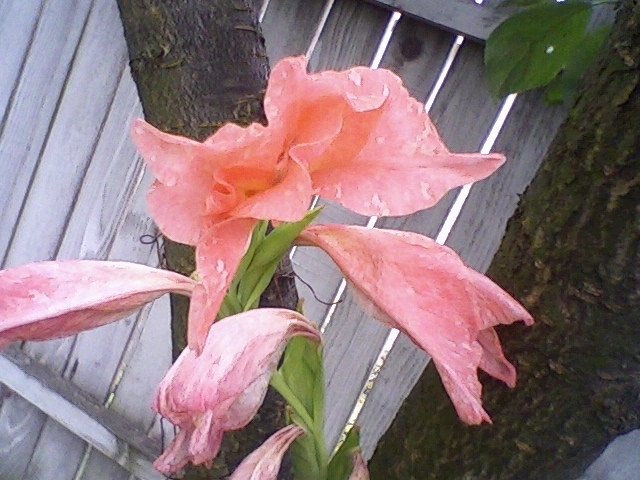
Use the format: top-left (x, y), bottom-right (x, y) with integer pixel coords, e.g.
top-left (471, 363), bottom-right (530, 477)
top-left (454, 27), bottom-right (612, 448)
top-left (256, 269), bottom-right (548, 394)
top-left (0, 260), bottom-right (195, 349)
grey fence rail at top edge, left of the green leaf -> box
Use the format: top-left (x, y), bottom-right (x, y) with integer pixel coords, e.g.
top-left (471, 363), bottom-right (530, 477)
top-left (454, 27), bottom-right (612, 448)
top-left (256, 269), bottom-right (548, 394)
top-left (367, 0), bottom-right (510, 40)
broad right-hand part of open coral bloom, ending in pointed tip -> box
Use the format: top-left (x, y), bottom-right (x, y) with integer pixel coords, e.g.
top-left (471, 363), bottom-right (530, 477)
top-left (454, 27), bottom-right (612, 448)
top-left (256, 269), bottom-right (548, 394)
top-left (265, 57), bottom-right (504, 216)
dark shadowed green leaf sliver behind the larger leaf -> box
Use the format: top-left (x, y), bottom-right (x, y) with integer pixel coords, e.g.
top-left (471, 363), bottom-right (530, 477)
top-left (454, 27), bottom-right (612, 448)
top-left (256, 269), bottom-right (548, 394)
top-left (544, 25), bottom-right (612, 105)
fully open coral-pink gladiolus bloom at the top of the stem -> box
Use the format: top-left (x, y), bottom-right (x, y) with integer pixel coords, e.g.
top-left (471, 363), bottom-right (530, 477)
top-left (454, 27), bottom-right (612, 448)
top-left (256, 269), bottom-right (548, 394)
top-left (132, 57), bottom-right (504, 350)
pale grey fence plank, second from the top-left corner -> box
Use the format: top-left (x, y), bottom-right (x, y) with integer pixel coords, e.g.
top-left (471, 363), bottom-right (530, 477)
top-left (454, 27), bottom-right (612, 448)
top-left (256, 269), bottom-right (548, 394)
top-left (0, 0), bottom-right (91, 265)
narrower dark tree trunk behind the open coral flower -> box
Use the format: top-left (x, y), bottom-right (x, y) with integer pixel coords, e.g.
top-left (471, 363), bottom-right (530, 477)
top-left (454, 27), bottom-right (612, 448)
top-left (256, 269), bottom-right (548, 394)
top-left (118, 0), bottom-right (297, 479)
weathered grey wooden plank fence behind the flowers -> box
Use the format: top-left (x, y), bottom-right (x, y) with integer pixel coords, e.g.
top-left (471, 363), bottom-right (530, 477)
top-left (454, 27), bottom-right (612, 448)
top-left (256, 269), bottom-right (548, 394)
top-left (0, 0), bottom-right (563, 480)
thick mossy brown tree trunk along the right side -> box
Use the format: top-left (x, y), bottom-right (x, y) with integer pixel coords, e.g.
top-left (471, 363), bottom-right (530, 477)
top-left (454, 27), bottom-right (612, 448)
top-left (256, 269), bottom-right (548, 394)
top-left (370, 0), bottom-right (640, 480)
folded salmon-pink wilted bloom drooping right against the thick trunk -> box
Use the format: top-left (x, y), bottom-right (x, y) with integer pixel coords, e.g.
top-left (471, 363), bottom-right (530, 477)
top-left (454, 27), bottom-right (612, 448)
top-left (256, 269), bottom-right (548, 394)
top-left (299, 225), bottom-right (533, 424)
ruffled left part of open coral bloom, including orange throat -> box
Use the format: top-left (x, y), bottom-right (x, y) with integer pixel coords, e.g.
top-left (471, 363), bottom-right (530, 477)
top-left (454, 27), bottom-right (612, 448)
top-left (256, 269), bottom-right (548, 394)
top-left (132, 116), bottom-right (298, 245)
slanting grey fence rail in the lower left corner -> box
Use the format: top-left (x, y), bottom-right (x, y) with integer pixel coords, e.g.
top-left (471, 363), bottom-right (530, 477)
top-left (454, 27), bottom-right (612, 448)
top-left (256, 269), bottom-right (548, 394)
top-left (0, 348), bottom-right (162, 478)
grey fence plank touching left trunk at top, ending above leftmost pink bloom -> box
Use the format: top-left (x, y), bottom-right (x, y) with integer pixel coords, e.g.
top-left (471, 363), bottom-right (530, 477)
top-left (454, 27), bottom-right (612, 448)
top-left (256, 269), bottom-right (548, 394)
top-left (5, 0), bottom-right (127, 266)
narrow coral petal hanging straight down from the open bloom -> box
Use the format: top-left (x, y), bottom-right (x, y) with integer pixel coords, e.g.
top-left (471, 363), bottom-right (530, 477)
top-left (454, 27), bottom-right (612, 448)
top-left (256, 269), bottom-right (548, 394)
top-left (188, 218), bottom-right (256, 352)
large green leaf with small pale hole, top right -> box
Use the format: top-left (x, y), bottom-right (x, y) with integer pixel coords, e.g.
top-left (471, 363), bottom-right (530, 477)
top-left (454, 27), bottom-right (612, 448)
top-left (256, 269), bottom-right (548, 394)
top-left (484, 0), bottom-right (591, 97)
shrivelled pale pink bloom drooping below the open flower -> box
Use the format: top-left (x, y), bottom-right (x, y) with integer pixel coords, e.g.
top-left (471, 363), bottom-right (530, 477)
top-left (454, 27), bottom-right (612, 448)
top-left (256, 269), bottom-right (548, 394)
top-left (153, 308), bottom-right (320, 475)
